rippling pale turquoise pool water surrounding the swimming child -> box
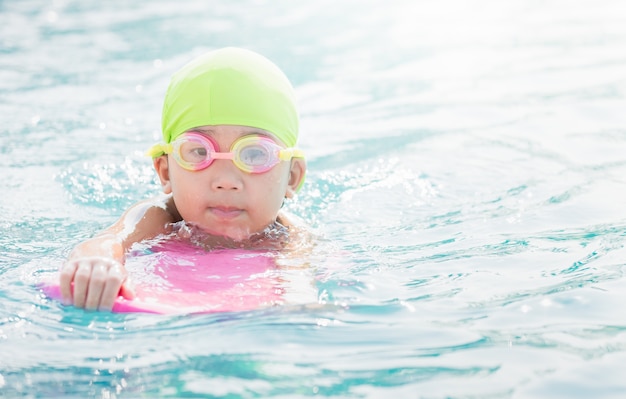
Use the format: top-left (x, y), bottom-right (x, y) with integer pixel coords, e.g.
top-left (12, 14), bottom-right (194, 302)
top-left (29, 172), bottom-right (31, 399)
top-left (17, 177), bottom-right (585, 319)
top-left (0, 0), bottom-right (626, 398)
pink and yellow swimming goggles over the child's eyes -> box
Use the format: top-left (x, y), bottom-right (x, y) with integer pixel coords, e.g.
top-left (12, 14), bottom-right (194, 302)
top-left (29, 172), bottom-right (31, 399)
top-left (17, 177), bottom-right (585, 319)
top-left (148, 131), bottom-right (304, 173)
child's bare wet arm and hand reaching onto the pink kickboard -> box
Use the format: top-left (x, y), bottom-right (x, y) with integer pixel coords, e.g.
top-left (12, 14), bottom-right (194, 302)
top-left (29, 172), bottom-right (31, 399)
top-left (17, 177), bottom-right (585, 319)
top-left (60, 198), bottom-right (177, 310)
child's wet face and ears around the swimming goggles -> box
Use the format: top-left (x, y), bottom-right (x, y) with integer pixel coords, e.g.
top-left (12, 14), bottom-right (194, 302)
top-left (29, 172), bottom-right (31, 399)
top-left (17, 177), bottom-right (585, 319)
top-left (154, 125), bottom-right (306, 240)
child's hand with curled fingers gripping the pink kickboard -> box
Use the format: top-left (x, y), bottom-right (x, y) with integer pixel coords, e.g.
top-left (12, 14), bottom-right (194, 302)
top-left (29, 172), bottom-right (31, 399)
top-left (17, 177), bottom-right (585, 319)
top-left (60, 257), bottom-right (135, 310)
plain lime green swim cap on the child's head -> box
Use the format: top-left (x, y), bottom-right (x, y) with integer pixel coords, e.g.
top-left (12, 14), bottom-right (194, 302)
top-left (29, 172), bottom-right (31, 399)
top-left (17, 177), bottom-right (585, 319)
top-left (151, 47), bottom-right (299, 151)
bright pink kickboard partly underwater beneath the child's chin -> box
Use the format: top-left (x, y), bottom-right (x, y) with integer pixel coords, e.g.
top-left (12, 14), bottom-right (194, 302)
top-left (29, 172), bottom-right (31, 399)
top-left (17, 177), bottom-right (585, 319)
top-left (40, 242), bottom-right (282, 314)
